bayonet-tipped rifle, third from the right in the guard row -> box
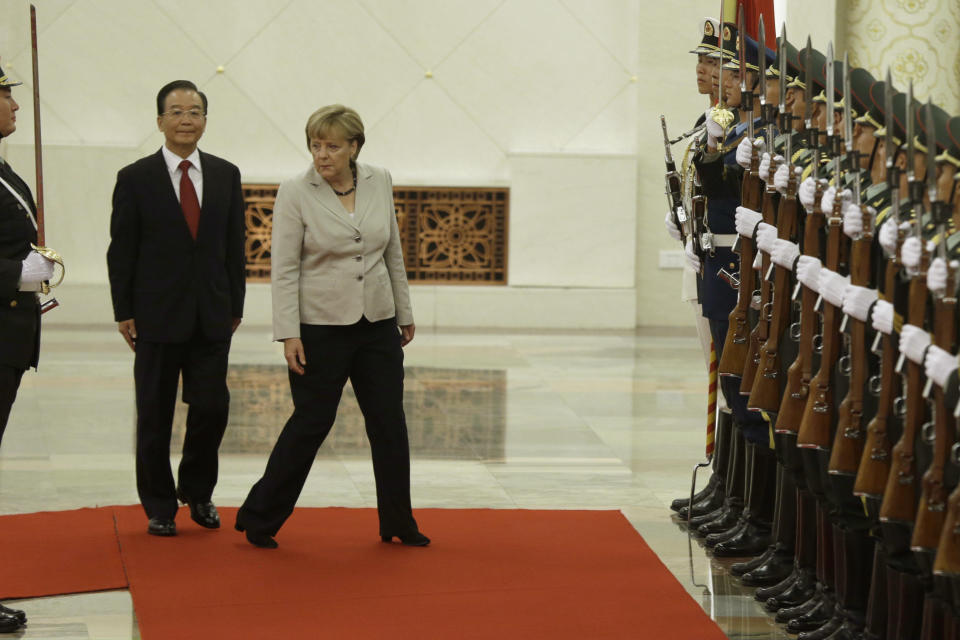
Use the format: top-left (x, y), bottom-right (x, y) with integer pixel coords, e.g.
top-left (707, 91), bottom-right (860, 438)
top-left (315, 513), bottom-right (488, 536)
top-left (880, 82), bottom-right (936, 524)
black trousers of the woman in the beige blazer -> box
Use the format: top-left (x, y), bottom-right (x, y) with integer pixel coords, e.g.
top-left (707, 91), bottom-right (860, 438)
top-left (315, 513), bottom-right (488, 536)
top-left (237, 318), bottom-right (417, 536)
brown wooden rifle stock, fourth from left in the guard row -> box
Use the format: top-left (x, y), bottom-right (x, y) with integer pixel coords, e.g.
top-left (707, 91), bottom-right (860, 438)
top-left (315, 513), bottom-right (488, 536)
top-left (774, 188), bottom-right (825, 434)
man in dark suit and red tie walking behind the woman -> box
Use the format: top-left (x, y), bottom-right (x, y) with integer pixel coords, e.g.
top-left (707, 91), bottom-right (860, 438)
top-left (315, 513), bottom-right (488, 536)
top-left (107, 80), bottom-right (246, 536)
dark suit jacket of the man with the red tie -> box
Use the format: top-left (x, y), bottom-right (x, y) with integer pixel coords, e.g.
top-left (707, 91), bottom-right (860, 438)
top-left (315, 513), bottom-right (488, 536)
top-left (107, 151), bottom-right (246, 343)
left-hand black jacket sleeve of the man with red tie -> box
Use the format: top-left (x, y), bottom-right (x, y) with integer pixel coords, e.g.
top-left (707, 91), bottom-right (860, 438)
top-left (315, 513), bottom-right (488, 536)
top-left (107, 171), bottom-right (140, 322)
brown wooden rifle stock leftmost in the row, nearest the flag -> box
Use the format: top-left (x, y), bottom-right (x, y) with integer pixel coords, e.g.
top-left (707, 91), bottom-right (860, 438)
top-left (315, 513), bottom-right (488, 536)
top-left (717, 166), bottom-right (763, 376)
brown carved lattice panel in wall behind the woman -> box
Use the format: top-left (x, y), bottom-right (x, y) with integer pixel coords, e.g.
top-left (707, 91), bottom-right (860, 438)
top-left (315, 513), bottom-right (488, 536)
top-left (243, 184), bottom-right (510, 285)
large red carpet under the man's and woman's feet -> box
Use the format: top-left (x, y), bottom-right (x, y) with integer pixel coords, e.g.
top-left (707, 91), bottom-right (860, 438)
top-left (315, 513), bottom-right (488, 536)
top-left (2, 507), bottom-right (725, 640)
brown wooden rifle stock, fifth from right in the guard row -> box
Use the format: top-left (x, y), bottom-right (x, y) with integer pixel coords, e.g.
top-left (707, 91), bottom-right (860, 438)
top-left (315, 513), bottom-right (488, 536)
top-left (827, 229), bottom-right (873, 476)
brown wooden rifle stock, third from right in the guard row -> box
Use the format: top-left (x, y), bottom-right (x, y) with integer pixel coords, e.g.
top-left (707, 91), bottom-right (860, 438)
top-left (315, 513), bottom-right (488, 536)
top-left (880, 268), bottom-right (927, 524)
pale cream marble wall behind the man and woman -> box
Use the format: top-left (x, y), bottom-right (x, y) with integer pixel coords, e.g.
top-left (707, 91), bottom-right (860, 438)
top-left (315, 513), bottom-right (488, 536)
top-left (0, 0), bottom-right (728, 328)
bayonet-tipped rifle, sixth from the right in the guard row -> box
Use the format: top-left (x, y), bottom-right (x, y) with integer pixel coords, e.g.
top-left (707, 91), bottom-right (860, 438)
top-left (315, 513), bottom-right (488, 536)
top-left (797, 42), bottom-right (844, 450)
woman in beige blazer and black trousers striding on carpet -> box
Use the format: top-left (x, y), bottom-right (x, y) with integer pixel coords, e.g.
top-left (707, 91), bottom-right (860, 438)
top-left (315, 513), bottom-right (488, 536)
top-left (236, 105), bottom-right (430, 548)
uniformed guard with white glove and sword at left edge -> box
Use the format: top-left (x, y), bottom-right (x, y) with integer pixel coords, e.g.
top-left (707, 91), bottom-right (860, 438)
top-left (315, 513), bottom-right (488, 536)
top-left (0, 58), bottom-right (53, 633)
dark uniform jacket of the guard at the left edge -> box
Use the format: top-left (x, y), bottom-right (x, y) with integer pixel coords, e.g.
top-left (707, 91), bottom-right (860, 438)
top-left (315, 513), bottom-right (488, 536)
top-left (0, 165), bottom-right (40, 369)
